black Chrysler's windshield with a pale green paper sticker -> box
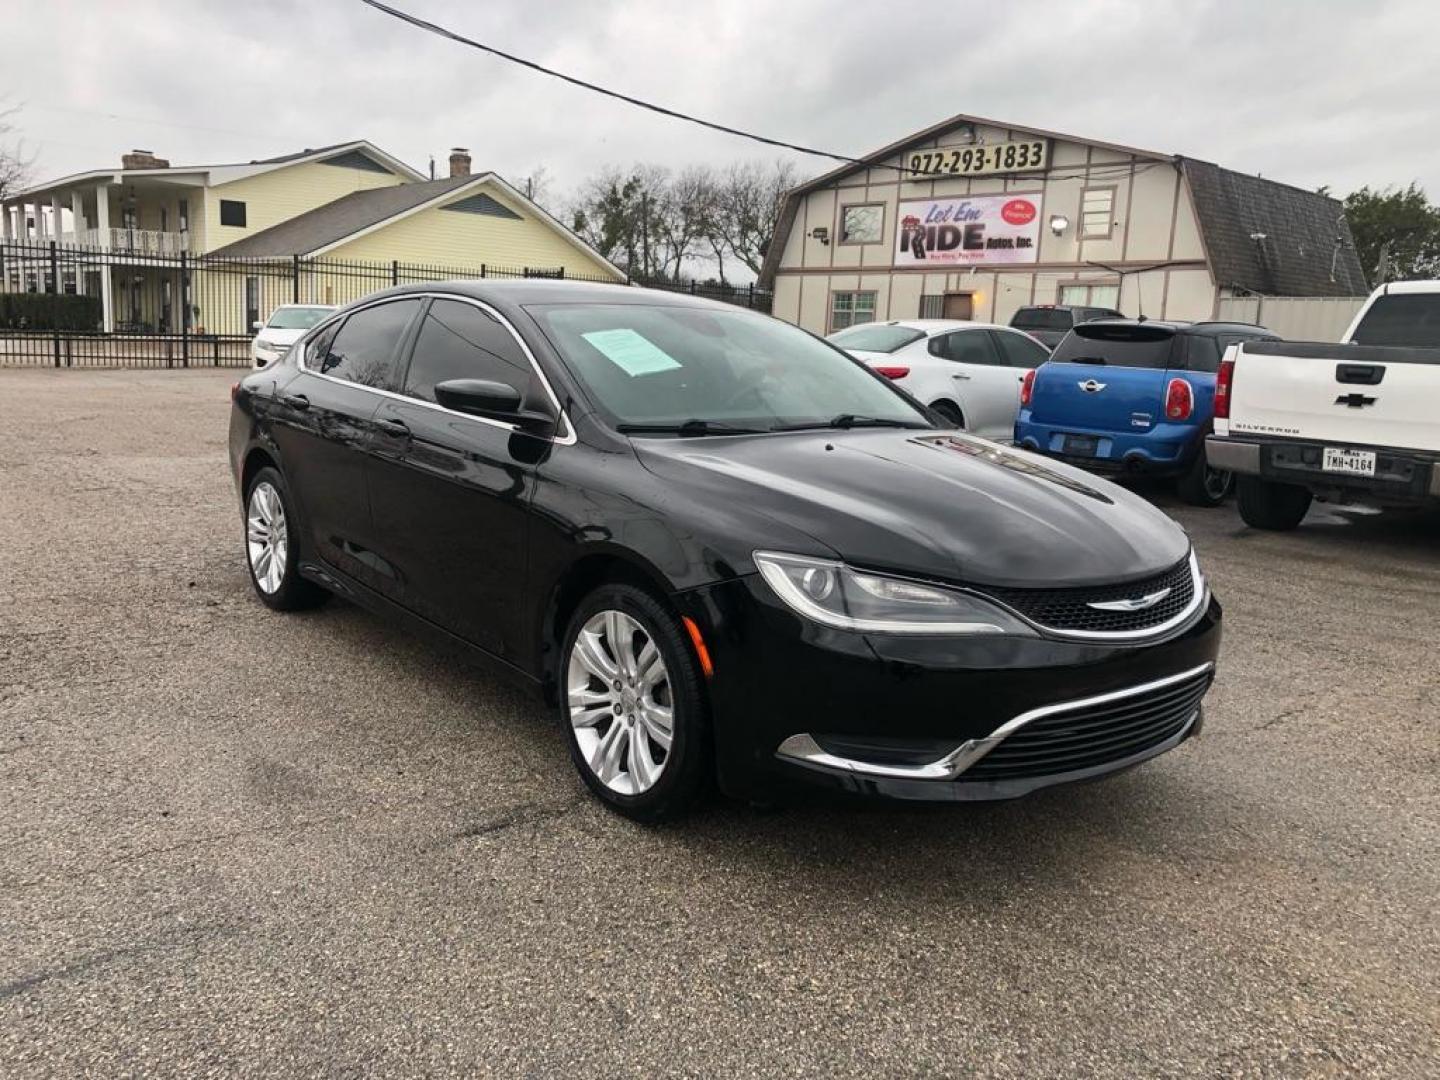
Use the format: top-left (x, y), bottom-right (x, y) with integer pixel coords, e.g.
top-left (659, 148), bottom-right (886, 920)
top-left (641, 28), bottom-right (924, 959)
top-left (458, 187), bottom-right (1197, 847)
top-left (528, 304), bottom-right (932, 435)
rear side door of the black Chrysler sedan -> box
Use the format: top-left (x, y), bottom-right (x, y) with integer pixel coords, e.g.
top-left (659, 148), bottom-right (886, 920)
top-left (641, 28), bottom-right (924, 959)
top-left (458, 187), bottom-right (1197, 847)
top-left (272, 300), bottom-right (422, 585)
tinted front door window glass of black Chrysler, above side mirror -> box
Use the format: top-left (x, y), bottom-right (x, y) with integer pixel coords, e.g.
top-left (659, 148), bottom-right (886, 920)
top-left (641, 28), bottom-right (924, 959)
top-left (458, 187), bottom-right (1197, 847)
top-left (405, 300), bottom-right (534, 402)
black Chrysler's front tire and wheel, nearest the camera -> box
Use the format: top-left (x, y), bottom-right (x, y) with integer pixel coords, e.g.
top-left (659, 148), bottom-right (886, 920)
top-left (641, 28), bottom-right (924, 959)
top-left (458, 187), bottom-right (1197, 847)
top-left (559, 585), bottom-right (710, 822)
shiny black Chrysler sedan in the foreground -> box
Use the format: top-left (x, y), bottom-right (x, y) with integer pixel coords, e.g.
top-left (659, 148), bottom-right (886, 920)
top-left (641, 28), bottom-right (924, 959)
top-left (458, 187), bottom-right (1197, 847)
top-left (230, 281), bottom-right (1220, 819)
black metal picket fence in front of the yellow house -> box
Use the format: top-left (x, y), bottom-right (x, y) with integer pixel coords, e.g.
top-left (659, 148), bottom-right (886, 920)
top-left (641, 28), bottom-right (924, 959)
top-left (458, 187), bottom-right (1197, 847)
top-left (0, 240), bottom-right (770, 367)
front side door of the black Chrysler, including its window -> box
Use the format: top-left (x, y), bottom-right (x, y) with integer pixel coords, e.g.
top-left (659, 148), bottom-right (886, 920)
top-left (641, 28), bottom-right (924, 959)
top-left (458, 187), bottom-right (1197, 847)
top-left (369, 298), bottom-right (552, 657)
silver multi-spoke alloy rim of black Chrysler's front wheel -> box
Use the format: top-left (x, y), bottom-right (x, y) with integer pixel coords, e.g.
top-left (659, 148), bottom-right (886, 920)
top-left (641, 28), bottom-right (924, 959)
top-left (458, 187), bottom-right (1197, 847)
top-left (566, 611), bottom-right (675, 795)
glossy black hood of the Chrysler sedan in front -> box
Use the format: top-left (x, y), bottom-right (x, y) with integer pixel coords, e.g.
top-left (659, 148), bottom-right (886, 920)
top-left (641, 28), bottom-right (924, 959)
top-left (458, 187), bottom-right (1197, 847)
top-left (634, 431), bottom-right (1189, 588)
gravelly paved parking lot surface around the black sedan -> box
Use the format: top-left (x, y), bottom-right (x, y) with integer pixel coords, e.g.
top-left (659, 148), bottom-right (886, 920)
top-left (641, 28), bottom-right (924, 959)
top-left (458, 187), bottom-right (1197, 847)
top-left (0, 370), bottom-right (1440, 1077)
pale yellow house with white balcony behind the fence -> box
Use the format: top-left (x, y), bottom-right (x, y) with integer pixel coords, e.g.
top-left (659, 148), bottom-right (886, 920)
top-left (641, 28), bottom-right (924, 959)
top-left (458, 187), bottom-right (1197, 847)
top-left (0, 140), bottom-right (625, 334)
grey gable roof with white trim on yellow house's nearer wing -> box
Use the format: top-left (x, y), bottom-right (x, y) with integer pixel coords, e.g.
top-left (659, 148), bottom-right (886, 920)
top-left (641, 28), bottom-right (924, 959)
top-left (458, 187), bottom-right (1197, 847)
top-left (210, 173), bottom-right (625, 279)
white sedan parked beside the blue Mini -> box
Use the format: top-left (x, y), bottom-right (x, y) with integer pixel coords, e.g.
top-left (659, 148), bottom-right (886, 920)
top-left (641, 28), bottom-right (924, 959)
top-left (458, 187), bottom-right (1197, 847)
top-left (825, 318), bottom-right (1050, 442)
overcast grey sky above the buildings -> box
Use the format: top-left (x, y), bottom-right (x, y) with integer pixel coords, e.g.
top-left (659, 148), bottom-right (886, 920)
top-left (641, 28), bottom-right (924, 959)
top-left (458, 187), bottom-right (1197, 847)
top-left (0, 0), bottom-right (1440, 202)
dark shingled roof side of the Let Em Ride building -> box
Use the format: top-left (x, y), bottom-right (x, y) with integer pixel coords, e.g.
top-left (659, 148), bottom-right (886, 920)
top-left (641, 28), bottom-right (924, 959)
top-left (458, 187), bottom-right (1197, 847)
top-left (1178, 158), bottom-right (1369, 297)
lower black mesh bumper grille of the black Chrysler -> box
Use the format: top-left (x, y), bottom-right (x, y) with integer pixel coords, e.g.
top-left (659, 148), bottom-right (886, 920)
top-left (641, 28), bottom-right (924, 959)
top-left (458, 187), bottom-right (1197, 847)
top-left (960, 668), bottom-right (1214, 780)
